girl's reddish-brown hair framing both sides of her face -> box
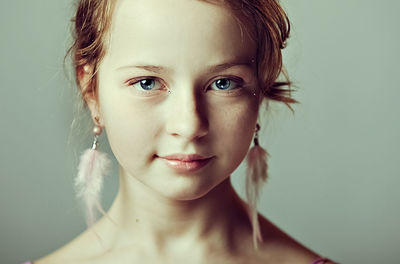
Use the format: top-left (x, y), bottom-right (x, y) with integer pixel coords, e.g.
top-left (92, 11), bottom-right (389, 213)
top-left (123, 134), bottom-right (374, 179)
top-left (67, 0), bottom-right (297, 111)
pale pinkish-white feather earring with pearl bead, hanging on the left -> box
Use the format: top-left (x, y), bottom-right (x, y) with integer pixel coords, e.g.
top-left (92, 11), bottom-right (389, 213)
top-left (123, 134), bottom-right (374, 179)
top-left (75, 117), bottom-right (111, 227)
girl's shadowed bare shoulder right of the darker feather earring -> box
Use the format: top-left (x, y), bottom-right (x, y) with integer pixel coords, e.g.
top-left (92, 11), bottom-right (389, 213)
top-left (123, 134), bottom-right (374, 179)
top-left (253, 215), bottom-right (333, 264)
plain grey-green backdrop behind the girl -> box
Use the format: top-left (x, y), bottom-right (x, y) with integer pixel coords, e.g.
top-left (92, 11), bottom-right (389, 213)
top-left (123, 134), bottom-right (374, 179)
top-left (0, 0), bottom-right (400, 264)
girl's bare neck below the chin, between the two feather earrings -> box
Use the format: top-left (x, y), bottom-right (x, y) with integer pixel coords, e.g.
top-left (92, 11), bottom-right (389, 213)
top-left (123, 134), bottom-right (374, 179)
top-left (101, 167), bottom-right (249, 254)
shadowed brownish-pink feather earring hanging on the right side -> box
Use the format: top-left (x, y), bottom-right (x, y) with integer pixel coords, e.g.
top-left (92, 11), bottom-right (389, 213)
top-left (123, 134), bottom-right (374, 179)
top-left (246, 124), bottom-right (268, 249)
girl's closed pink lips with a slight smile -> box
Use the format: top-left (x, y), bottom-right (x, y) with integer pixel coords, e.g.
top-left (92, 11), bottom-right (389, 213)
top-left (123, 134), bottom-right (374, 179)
top-left (159, 154), bottom-right (213, 173)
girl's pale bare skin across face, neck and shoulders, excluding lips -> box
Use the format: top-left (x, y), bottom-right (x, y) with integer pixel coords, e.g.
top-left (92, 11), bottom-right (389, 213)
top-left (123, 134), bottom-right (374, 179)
top-left (37, 0), bottom-right (332, 264)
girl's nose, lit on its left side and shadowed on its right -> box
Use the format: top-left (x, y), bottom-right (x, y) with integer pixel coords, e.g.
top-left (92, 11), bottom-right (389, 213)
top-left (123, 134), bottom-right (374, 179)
top-left (166, 87), bottom-right (209, 141)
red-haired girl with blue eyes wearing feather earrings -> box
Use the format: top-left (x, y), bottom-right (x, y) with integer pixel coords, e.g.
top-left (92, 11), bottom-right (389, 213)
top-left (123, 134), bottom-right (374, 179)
top-left (25, 0), bottom-right (332, 264)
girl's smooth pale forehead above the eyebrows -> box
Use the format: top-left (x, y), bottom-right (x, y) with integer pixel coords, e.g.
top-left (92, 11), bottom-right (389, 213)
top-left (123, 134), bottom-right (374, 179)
top-left (101, 0), bottom-right (255, 69)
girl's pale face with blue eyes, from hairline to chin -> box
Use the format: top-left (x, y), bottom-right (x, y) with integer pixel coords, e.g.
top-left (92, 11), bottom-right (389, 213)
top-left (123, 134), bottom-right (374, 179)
top-left (89, 0), bottom-right (261, 200)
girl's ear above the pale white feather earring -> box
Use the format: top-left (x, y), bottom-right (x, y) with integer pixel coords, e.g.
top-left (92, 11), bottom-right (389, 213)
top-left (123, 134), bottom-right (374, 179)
top-left (76, 64), bottom-right (103, 127)
